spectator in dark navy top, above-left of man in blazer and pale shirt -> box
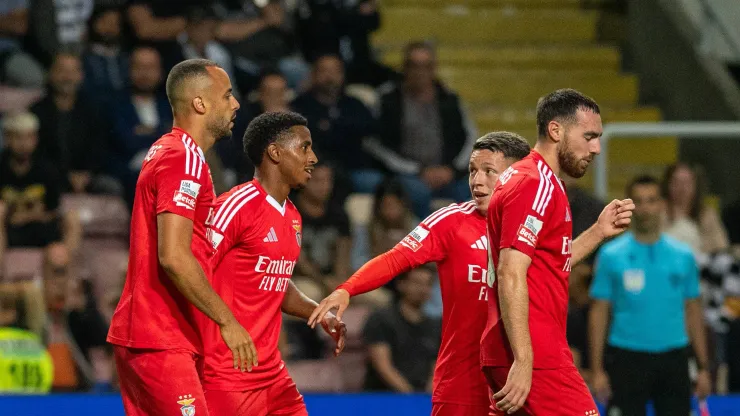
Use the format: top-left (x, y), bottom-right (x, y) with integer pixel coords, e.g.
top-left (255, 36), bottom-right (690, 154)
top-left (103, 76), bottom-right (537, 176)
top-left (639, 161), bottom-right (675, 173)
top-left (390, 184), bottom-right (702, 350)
top-left (82, 7), bottom-right (128, 99)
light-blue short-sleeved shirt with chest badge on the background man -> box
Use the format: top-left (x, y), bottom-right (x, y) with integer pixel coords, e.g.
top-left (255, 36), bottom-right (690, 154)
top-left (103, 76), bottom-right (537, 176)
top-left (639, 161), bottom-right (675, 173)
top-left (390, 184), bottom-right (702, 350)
top-left (591, 233), bottom-right (699, 353)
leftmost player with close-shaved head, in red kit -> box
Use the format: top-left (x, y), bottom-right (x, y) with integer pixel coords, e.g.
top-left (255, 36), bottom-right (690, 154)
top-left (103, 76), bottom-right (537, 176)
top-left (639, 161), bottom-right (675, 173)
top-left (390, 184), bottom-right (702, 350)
top-left (108, 59), bottom-right (257, 416)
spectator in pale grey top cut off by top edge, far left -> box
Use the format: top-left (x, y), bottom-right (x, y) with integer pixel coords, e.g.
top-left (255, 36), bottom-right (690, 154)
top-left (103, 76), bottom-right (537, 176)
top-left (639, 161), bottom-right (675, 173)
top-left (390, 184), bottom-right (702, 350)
top-left (26, 0), bottom-right (95, 67)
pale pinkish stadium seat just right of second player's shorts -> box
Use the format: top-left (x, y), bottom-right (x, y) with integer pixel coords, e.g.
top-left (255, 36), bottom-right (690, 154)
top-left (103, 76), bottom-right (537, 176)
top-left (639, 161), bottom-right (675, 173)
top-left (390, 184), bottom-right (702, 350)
top-left (287, 359), bottom-right (344, 393)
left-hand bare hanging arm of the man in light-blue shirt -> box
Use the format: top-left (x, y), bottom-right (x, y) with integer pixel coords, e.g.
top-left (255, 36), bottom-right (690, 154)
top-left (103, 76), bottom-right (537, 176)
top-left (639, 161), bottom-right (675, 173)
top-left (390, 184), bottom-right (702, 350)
top-left (588, 299), bottom-right (611, 401)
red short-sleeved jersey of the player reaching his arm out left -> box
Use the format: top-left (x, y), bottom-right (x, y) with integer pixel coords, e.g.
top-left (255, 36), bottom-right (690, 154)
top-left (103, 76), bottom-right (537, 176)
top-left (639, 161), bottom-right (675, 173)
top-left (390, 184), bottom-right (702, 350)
top-left (393, 201), bottom-right (489, 406)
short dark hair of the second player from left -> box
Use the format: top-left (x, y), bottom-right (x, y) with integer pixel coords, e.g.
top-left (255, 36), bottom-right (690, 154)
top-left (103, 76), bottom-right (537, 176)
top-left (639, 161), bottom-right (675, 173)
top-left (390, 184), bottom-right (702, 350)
top-left (244, 111), bottom-right (308, 166)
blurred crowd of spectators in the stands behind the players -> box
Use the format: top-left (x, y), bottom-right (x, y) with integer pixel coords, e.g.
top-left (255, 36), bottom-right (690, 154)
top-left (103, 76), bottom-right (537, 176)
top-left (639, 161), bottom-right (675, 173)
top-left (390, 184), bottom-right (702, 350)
top-left (0, 0), bottom-right (740, 400)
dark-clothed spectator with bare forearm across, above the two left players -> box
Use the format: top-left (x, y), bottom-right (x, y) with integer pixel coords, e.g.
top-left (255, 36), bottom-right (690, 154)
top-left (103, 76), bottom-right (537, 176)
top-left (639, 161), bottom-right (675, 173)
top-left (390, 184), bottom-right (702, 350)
top-left (217, 0), bottom-right (309, 90)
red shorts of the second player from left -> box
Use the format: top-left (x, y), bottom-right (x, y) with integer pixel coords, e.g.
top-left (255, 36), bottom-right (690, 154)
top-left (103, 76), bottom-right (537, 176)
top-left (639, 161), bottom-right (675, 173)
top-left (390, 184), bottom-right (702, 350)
top-left (206, 368), bottom-right (308, 416)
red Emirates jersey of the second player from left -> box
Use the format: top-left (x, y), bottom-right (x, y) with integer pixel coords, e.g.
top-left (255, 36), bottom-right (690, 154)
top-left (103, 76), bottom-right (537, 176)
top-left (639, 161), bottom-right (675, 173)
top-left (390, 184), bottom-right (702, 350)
top-left (203, 180), bottom-right (302, 391)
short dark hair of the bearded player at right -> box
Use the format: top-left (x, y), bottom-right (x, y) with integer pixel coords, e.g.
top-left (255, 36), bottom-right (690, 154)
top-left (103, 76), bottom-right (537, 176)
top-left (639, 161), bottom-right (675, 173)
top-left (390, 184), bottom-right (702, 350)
top-left (537, 88), bottom-right (601, 137)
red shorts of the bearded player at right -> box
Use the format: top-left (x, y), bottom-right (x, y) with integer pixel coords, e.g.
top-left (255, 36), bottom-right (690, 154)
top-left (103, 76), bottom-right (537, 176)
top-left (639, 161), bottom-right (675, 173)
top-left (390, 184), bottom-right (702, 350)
top-left (483, 367), bottom-right (599, 416)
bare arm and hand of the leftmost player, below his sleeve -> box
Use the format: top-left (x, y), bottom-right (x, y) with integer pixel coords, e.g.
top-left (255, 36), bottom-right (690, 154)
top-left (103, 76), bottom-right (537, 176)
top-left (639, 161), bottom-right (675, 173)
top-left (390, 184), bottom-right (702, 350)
top-left (157, 212), bottom-right (257, 371)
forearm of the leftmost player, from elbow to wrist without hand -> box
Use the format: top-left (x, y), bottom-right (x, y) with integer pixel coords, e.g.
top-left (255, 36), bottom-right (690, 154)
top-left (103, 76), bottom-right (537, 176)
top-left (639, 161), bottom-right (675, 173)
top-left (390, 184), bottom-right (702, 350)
top-left (160, 252), bottom-right (235, 326)
